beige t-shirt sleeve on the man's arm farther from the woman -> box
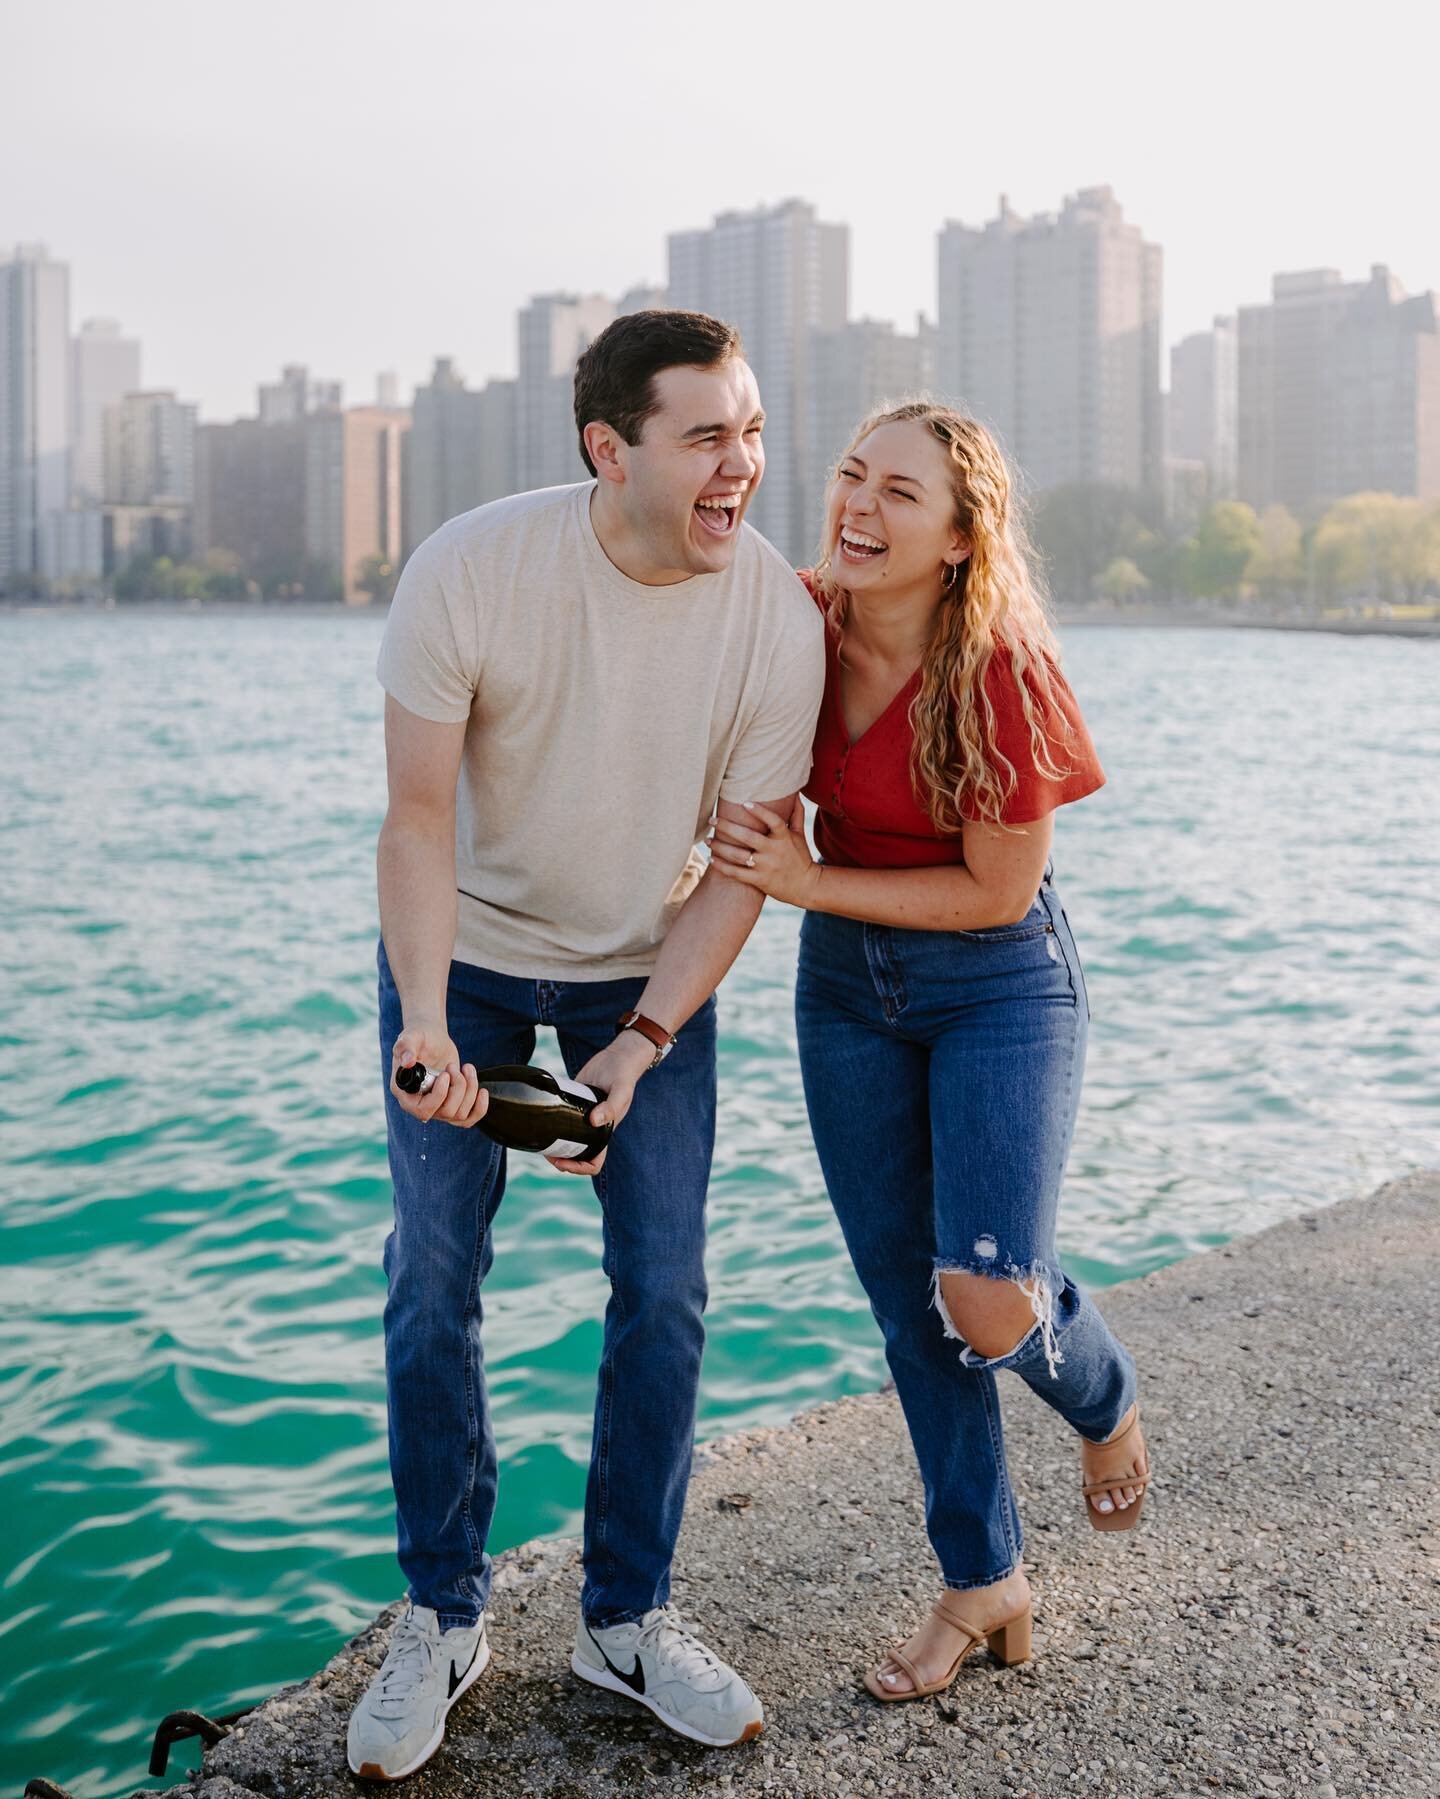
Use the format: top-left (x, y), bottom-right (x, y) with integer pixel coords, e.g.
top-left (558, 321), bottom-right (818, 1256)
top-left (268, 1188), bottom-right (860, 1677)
top-left (374, 531), bottom-right (477, 725)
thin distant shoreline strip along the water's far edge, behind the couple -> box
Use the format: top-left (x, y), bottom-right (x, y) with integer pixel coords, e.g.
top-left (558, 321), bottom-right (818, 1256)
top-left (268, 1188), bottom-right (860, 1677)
top-left (0, 599), bottom-right (1440, 639)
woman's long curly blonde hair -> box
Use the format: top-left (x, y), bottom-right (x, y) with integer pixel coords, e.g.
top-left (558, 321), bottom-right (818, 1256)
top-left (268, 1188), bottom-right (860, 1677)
top-left (814, 399), bottom-right (1073, 835)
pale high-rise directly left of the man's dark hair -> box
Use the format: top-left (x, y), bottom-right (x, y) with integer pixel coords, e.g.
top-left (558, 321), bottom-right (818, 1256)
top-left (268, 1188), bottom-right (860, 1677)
top-left (515, 293), bottom-right (617, 491)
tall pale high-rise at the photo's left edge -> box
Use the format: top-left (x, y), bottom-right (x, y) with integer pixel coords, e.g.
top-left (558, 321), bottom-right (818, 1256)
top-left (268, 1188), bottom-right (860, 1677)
top-left (0, 245), bottom-right (70, 581)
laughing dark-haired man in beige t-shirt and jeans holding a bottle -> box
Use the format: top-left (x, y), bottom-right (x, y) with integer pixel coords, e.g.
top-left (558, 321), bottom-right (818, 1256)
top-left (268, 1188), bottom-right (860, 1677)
top-left (349, 311), bottom-right (824, 1779)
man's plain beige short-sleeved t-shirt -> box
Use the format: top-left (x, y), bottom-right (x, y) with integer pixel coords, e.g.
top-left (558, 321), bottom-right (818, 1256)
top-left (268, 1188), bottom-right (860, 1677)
top-left (378, 482), bottom-right (824, 980)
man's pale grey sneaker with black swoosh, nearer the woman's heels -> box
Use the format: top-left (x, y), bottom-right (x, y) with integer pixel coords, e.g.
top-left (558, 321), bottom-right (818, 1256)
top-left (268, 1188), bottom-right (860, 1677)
top-left (571, 1605), bottom-right (765, 1749)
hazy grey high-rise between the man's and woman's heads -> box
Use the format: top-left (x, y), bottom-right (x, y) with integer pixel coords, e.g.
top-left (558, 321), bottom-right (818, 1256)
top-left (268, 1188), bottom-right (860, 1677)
top-left (802, 317), bottom-right (934, 556)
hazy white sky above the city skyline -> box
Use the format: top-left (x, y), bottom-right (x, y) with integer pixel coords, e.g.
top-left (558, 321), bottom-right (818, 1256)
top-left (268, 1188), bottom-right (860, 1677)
top-left (0, 0), bottom-right (1440, 417)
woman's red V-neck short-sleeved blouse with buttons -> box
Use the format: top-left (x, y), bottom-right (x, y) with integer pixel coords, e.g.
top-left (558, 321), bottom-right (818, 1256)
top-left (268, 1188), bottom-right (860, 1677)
top-left (801, 570), bottom-right (1105, 869)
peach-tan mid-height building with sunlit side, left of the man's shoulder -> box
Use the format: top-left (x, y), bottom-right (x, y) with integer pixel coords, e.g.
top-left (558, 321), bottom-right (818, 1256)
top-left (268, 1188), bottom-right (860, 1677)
top-left (304, 407), bottom-right (410, 606)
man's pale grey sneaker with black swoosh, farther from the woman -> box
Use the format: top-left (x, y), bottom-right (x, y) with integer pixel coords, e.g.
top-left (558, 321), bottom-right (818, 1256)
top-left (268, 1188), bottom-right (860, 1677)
top-left (346, 1605), bottom-right (490, 1781)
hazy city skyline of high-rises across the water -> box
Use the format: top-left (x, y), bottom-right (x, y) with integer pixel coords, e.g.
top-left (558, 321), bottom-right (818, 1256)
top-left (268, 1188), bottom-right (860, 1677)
top-left (0, 187), bottom-right (1440, 603)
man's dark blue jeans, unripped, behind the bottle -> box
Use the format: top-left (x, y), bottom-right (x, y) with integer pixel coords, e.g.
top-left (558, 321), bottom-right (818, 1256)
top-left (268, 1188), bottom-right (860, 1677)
top-left (378, 943), bottom-right (715, 1630)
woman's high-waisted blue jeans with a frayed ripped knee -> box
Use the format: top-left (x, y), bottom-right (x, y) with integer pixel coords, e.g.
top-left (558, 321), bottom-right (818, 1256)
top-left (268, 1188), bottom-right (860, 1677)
top-left (796, 876), bottom-right (1136, 1587)
